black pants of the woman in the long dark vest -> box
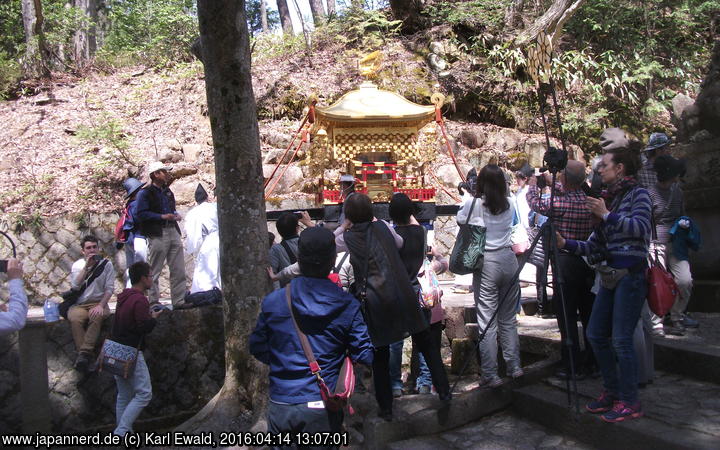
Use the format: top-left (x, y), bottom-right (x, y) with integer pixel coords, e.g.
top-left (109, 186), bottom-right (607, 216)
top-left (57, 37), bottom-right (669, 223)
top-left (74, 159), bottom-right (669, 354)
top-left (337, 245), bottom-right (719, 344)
top-left (373, 328), bottom-right (450, 412)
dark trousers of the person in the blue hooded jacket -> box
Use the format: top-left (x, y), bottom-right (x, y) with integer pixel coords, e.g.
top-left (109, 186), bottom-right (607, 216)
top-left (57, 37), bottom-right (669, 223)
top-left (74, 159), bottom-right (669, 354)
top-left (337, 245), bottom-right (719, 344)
top-left (267, 401), bottom-right (343, 449)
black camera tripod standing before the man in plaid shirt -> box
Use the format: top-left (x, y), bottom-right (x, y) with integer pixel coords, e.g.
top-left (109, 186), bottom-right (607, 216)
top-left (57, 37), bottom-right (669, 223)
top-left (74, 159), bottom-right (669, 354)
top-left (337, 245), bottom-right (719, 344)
top-left (450, 167), bottom-right (580, 413)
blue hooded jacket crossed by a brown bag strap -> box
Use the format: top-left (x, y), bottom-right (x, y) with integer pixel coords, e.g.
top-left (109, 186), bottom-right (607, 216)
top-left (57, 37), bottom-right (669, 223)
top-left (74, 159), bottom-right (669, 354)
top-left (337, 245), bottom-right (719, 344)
top-left (250, 277), bottom-right (373, 404)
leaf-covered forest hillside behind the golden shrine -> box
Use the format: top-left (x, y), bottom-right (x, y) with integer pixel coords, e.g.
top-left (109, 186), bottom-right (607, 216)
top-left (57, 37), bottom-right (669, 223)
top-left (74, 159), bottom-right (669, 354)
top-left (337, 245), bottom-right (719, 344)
top-left (0, 0), bottom-right (720, 226)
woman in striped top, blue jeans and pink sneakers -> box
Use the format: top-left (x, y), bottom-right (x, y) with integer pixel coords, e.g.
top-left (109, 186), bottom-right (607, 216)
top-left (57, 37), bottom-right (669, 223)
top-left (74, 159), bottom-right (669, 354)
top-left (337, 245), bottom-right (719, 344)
top-left (557, 143), bottom-right (651, 422)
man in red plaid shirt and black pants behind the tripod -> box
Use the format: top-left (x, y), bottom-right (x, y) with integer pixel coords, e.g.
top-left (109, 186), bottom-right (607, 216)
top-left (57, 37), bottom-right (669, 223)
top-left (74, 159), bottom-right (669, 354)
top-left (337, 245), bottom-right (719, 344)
top-left (527, 160), bottom-right (595, 379)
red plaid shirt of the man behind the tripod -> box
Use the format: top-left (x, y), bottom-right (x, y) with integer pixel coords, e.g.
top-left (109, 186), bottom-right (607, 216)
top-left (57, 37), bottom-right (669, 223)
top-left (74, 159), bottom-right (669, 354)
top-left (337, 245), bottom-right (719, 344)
top-left (527, 185), bottom-right (593, 241)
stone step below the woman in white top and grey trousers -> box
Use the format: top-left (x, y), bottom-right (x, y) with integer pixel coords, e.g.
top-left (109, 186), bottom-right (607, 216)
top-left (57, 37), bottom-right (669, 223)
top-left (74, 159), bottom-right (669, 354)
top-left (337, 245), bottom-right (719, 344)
top-left (360, 360), bottom-right (554, 449)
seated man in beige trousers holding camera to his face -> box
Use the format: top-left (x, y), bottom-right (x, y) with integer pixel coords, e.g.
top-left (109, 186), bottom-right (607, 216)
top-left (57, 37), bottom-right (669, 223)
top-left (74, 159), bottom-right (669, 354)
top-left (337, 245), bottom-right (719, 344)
top-left (67, 235), bottom-right (115, 372)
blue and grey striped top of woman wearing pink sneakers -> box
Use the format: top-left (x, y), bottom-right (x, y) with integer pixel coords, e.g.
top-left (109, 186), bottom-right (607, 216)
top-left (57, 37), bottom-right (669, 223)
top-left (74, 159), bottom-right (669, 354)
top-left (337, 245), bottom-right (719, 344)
top-left (565, 186), bottom-right (652, 269)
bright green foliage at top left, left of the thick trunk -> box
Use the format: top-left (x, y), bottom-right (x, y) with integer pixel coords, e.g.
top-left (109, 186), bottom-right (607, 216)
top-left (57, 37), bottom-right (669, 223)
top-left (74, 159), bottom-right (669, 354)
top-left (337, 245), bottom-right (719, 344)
top-left (98, 0), bottom-right (199, 66)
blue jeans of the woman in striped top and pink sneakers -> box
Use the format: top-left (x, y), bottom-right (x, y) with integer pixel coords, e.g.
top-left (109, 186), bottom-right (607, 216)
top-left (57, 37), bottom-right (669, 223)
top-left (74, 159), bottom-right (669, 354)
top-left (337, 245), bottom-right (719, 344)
top-left (587, 270), bottom-right (647, 404)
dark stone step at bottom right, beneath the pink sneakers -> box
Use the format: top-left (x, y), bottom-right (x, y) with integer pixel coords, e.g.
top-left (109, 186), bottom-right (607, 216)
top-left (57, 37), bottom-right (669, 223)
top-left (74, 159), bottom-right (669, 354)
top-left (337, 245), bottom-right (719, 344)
top-left (512, 379), bottom-right (720, 449)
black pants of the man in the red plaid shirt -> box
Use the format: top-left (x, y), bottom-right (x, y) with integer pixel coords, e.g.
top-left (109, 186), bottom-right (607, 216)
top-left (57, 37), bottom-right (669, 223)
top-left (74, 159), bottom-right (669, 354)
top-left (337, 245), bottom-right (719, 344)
top-left (553, 253), bottom-right (596, 372)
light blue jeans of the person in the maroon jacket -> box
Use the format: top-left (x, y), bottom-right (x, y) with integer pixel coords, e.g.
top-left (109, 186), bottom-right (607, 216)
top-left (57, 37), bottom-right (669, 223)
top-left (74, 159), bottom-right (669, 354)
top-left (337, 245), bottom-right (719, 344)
top-left (113, 352), bottom-right (152, 436)
